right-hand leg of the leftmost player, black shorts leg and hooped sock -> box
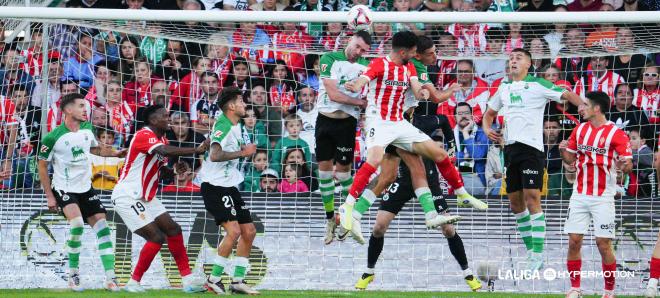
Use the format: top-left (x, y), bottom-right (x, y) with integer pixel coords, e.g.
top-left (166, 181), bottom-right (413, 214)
top-left (79, 188), bottom-right (120, 292)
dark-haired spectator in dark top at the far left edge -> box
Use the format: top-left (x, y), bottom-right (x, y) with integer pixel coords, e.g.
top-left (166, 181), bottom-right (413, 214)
top-left (0, 44), bottom-right (34, 96)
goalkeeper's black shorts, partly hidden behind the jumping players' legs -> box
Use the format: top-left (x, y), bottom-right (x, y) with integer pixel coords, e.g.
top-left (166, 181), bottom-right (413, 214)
top-left (378, 160), bottom-right (449, 214)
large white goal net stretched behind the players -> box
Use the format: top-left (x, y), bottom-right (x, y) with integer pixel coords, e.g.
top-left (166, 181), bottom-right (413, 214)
top-left (0, 5), bottom-right (660, 294)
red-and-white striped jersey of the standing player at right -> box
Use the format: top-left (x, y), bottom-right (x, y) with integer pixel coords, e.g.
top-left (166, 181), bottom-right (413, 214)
top-left (566, 121), bottom-right (632, 197)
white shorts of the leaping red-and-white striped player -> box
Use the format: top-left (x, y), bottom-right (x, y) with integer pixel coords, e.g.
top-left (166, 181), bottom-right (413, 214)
top-left (366, 117), bottom-right (431, 152)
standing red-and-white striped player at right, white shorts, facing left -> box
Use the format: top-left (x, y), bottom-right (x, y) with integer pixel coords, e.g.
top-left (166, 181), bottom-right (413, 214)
top-left (559, 91), bottom-right (632, 298)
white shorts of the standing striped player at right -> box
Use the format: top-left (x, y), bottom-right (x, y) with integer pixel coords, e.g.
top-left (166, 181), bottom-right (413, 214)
top-left (564, 194), bottom-right (616, 239)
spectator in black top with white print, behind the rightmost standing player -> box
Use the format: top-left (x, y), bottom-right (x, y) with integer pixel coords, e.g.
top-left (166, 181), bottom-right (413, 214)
top-left (608, 83), bottom-right (652, 138)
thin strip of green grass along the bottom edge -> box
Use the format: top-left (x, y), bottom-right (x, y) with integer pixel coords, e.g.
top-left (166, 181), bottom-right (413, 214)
top-left (0, 289), bottom-right (636, 298)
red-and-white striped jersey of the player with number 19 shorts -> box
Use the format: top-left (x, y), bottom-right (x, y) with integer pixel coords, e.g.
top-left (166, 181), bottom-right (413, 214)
top-left (115, 127), bottom-right (168, 201)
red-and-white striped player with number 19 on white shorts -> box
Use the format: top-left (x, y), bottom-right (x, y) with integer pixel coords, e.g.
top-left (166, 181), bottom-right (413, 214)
top-left (112, 105), bottom-right (208, 293)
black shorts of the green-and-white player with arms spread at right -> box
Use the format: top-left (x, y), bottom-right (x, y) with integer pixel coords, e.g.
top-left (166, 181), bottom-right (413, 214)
top-left (504, 143), bottom-right (545, 193)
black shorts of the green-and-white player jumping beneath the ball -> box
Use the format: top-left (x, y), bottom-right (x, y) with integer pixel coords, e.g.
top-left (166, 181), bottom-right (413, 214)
top-left (314, 114), bottom-right (357, 165)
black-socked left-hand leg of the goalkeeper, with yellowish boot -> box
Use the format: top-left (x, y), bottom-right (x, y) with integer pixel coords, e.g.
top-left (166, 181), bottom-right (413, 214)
top-left (355, 208), bottom-right (398, 290)
